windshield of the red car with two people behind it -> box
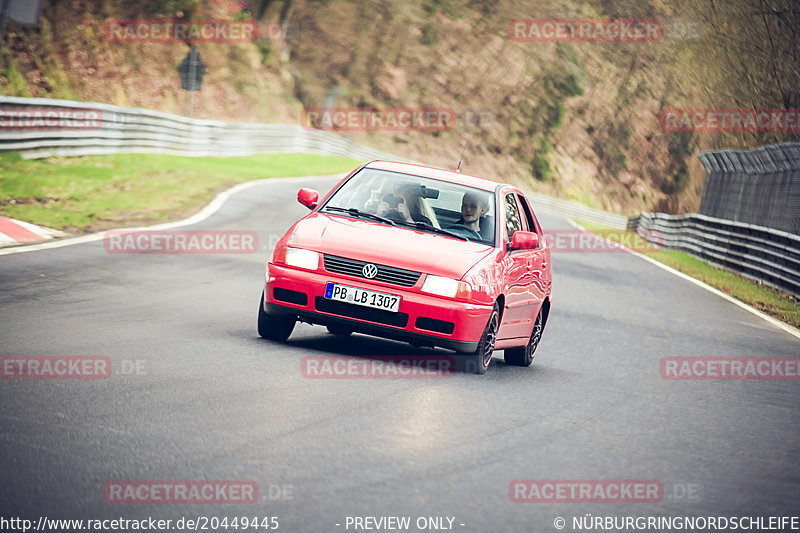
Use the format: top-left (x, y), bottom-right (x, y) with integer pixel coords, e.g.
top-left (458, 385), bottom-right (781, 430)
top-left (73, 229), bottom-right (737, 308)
top-left (322, 168), bottom-right (496, 246)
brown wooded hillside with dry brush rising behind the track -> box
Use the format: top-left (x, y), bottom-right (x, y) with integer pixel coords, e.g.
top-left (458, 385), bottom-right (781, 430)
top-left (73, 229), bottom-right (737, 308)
top-left (0, 0), bottom-right (800, 214)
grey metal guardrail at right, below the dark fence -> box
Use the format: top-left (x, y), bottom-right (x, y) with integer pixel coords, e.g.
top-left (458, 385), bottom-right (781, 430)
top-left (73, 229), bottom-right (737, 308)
top-left (628, 213), bottom-right (800, 298)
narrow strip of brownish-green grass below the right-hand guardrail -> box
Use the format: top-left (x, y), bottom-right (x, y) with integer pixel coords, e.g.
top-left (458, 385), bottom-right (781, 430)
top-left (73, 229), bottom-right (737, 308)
top-left (578, 221), bottom-right (800, 327)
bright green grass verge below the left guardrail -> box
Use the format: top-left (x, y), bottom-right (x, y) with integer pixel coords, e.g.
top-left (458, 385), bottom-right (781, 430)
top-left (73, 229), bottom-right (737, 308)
top-left (0, 153), bottom-right (360, 233)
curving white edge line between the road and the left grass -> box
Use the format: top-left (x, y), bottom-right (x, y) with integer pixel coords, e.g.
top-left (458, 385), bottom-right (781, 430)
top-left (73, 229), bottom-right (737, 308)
top-left (0, 172), bottom-right (347, 255)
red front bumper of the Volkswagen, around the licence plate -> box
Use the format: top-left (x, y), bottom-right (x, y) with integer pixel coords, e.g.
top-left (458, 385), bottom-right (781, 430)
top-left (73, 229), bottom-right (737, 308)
top-left (263, 263), bottom-right (492, 353)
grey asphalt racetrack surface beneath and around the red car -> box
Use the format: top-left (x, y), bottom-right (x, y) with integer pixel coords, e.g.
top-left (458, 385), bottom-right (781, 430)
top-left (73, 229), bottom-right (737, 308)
top-left (0, 179), bottom-right (800, 532)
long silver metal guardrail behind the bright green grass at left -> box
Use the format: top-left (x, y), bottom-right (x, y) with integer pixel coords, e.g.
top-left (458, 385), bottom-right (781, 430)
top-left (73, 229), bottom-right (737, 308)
top-left (0, 96), bottom-right (404, 161)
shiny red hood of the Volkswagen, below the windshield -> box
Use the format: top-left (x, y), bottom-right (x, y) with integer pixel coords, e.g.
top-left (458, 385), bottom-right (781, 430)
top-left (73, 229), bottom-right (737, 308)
top-left (289, 213), bottom-right (494, 279)
